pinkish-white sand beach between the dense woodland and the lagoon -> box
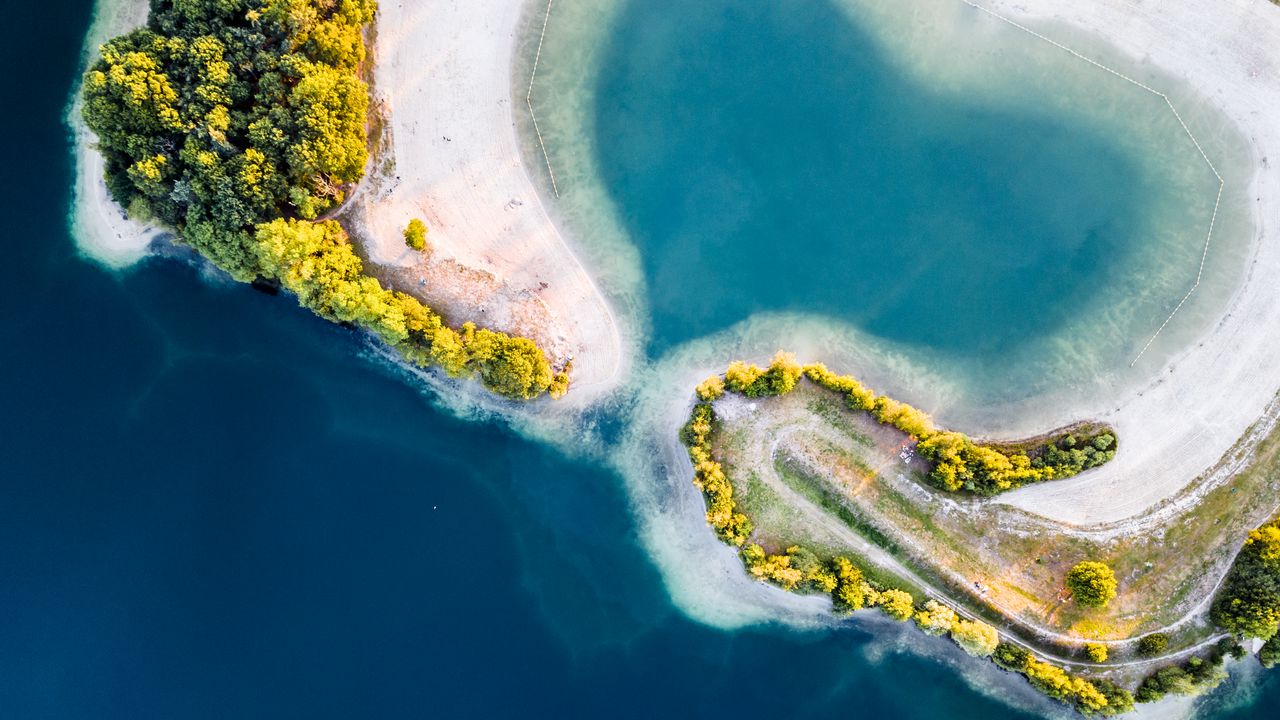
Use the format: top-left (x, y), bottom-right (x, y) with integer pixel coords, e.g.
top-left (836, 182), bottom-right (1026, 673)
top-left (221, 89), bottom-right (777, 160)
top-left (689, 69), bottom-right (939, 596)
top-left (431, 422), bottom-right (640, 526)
top-left (347, 0), bottom-right (626, 402)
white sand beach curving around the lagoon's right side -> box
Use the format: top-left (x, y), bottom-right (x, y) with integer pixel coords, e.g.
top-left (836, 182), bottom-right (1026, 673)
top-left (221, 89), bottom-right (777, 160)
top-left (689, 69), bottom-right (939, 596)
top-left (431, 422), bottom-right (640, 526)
top-left (975, 0), bottom-right (1280, 525)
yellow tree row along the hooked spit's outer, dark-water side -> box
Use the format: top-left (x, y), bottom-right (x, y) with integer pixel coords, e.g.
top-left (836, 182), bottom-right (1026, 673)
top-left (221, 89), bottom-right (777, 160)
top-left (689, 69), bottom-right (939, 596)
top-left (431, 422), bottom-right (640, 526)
top-left (681, 394), bottom-right (1134, 715)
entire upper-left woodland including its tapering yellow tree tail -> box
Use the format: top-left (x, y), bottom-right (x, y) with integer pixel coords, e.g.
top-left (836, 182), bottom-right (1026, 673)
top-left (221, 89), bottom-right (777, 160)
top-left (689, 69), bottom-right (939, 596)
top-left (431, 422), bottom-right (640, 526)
top-left (83, 0), bottom-right (568, 400)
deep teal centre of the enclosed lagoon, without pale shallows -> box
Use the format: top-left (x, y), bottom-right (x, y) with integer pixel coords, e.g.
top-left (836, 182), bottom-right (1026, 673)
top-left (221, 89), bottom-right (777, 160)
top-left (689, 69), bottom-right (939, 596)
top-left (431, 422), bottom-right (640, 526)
top-left (594, 0), bottom-right (1167, 353)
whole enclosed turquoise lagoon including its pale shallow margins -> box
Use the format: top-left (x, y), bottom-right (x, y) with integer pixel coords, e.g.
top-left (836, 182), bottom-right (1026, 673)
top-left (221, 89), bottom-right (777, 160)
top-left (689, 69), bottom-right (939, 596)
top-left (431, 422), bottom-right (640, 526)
top-left (527, 0), bottom-right (1251, 420)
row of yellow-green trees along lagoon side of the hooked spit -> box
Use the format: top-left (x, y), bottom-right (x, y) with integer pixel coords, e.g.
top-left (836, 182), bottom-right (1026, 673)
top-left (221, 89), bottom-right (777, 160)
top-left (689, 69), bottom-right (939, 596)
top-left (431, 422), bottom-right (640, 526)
top-left (698, 352), bottom-right (1116, 496)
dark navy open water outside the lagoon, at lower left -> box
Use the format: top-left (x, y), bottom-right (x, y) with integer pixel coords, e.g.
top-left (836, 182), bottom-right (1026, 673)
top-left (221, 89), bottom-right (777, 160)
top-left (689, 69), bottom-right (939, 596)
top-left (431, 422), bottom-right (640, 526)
top-left (0, 0), bottom-right (1280, 720)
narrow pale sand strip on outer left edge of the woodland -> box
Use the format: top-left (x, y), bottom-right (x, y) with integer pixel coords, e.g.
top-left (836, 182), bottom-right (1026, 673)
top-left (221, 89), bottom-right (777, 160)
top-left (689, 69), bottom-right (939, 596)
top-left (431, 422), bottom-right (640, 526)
top-left (67, 0), bottom-right (163, 268)
